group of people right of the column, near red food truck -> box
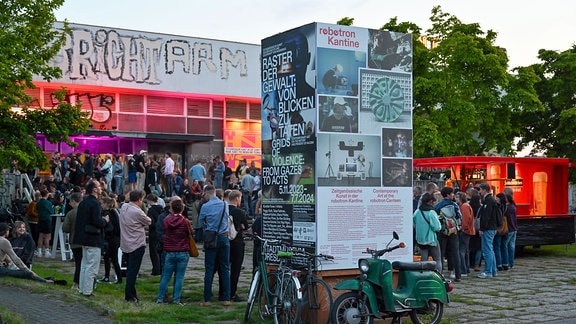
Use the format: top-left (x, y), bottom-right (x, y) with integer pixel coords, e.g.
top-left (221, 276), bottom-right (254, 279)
top-left (413, 182), bottom-right (518, 282)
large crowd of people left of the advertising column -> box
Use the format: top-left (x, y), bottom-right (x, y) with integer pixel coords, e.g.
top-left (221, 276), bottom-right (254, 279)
top-left (0, 150), bottom-right (261, 306)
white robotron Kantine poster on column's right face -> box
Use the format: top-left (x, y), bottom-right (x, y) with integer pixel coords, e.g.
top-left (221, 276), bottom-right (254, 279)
top-left (315, 23), bottom-right (412, 270)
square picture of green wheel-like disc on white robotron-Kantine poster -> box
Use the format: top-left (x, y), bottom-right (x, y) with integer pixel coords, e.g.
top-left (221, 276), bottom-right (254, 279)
top-left (359, 69), bottom-right (412, 133)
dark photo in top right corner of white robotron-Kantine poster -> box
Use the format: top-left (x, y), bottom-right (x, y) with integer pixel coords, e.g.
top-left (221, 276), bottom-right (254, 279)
top-left (368, 30), bottom-right (412, 72)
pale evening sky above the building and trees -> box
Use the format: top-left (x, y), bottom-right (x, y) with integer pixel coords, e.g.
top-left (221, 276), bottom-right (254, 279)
top-left (56, 0), bottom-right (576, 68)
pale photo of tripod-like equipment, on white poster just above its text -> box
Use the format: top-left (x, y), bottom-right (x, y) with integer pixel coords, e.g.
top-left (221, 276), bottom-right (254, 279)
top-left (316, 133), bottom-right (381, 187)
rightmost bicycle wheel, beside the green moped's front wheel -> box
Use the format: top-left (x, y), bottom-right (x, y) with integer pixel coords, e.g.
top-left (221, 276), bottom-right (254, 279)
top-left (300, 278), bottom-right (332, 323)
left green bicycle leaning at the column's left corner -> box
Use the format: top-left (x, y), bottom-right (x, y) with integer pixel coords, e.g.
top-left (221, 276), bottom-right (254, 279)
top-left (244, 235), bottom-right (302, 324)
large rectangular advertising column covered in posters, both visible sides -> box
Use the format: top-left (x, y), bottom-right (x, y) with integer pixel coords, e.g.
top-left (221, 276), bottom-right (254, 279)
top-left (261, 23), bottom-right (413, 270)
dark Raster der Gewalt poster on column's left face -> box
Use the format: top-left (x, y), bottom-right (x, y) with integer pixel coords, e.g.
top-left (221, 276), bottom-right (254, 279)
top-left (261, 24), bottom-right (317, 261)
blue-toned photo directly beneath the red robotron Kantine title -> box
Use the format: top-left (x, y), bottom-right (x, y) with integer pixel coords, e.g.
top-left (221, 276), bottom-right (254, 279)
top-left (317, 48), bottom-right (366, 96)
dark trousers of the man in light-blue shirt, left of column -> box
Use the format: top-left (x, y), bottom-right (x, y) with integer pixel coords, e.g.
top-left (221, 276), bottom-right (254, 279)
top-left (204, 235), bottom-right (230, 301)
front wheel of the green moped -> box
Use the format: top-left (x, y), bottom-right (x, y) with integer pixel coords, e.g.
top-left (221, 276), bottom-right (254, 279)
top-left (330, 291), bottom-right (373, 324)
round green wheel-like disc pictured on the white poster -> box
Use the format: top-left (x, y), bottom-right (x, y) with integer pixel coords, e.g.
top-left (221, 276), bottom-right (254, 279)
top-left (369, 77), bottom-right (404, 122)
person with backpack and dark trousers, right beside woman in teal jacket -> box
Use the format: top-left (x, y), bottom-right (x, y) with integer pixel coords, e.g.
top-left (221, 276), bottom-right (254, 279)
top-left (434, 187), bottom-right (462, 282)
